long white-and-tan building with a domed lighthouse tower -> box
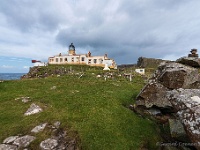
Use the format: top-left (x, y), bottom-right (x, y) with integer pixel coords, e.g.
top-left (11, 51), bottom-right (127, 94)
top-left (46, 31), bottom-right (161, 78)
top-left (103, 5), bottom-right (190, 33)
top-left (48, 43), bottom-right (117, 68)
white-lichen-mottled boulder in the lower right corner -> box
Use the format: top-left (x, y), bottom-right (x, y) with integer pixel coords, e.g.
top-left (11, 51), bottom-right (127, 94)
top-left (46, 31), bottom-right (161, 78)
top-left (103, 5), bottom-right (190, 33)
top-left (167, 89), bottom-right (200, 150)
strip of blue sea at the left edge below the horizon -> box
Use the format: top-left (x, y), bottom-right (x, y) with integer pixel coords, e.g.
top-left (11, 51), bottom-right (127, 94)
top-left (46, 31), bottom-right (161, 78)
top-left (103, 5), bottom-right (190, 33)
top-left (0, 73), bottom-right (26, 80)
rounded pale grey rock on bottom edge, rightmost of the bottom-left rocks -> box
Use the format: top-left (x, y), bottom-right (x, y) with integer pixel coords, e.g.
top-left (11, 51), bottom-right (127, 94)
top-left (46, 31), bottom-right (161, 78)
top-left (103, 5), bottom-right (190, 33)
top-left (40, 138), bottom-right (58, 150)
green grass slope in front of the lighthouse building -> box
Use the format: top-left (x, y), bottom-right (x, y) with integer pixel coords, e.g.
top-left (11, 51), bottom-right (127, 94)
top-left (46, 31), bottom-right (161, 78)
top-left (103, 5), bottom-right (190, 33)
top-left (0, 73), bottom-right (160, 150)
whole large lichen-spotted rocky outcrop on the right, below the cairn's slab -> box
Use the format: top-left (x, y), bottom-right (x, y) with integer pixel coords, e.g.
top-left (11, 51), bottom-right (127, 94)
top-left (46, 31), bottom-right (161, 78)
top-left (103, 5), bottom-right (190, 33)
top-left (134, 62), bottom-right (200, 150)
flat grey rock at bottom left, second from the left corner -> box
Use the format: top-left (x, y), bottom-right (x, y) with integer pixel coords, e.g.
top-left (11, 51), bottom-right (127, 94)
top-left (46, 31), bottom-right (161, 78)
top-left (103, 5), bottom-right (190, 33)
top-left (13, 135), bottom-right (36, 147)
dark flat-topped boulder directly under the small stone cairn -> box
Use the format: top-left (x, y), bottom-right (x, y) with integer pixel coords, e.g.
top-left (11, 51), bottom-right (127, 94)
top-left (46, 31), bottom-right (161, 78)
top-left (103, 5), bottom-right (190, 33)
top-left (176, 57), bottom-right (200, 68)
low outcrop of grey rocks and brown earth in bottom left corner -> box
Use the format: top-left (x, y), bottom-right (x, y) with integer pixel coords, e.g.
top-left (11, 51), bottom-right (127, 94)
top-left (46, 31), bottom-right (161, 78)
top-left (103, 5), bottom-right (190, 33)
top-left (0, 121), bottom-right (80, 150)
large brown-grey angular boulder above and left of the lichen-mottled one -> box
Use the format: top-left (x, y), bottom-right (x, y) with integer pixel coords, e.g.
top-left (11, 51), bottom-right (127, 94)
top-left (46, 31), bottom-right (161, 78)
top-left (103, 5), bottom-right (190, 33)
top-left (136, 62), bottom-right (199, 108)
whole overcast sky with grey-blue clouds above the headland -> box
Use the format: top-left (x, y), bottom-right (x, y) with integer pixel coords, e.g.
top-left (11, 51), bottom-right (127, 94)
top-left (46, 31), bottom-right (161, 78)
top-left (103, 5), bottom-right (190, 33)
top-left (0, 0), bottom-right (200, 73)
